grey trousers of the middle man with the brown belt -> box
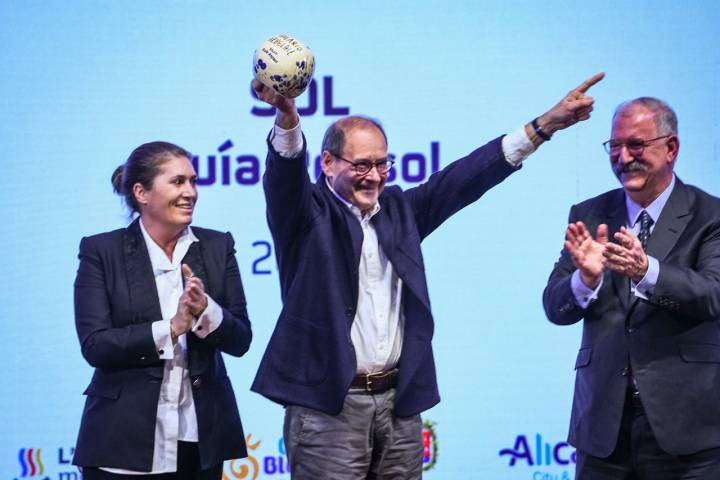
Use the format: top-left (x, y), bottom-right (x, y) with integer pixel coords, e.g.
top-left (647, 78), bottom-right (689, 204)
top-left (283, 388), bottom-right (423, 480)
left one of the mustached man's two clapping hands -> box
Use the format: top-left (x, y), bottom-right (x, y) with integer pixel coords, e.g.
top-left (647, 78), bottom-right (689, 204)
top-left (565, 222), bottom-right (608, 288)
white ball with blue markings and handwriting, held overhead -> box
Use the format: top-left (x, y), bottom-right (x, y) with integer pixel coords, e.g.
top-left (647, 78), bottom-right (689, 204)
top-left (253, 35), bottom-right (315, 98)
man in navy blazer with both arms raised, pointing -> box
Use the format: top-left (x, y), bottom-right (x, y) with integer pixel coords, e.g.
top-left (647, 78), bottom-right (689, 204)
top-left (252, 74), bottom-right (603, 480)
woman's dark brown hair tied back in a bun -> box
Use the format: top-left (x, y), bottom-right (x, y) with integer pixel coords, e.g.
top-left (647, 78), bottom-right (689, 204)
top-left (111, 142), bottom-right (192, 213)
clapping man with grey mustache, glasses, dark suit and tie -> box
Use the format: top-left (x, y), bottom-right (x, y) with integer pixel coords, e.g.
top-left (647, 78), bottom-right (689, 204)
top-left (543, 97), bottom-right (720, 480)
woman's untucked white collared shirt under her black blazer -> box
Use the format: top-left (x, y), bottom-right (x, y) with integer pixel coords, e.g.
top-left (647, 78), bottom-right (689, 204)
top-left (100, 218), bottom-right (222, 475)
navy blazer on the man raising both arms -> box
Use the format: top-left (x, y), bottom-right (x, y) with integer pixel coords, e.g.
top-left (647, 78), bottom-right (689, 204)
top-left (252, 134), bottom-right (515, 416)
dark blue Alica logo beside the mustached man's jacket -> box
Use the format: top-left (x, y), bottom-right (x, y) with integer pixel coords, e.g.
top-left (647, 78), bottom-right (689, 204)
top-left (499, 433), bottom-right (576, 480)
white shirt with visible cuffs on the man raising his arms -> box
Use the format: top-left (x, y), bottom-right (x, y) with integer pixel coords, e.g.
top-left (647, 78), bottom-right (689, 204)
top-left (270, 123), bottom-right (535, 374)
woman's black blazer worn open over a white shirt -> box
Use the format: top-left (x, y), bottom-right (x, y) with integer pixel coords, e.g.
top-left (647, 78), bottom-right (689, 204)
top-left (73, 220), bottom-right (252, 471)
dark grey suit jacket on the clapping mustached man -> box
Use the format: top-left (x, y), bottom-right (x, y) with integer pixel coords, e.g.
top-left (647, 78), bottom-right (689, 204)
top-left (543, 179), bottom-right (720, 457)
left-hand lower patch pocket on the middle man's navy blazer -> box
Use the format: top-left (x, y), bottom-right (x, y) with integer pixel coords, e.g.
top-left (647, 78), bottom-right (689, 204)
top-left (269, 315), bottom-right (331, 385)
